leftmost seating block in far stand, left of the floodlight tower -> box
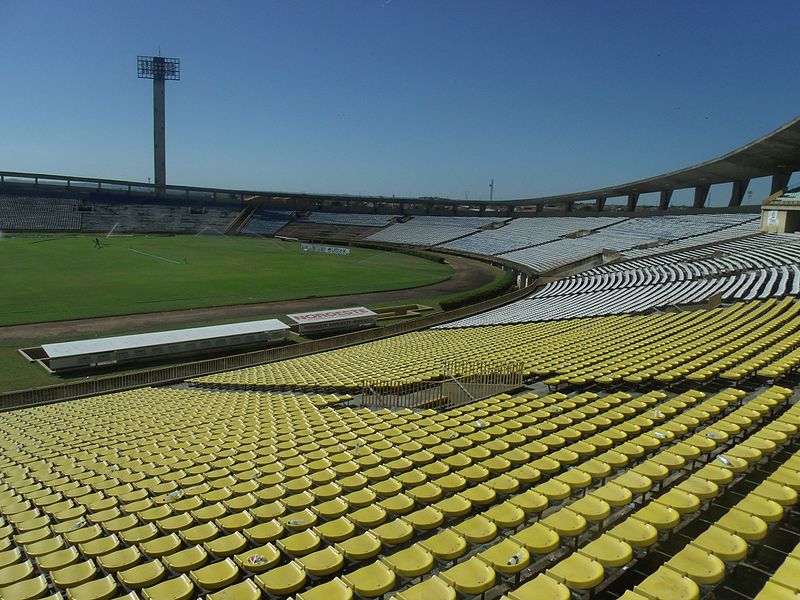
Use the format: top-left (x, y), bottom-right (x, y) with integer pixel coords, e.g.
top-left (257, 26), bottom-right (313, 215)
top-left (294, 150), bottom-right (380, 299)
top-left (0, 194), bottom-right (81, 231)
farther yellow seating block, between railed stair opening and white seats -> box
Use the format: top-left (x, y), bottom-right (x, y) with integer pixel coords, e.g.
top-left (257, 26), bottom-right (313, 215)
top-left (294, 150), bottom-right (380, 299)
top-left (194, 297), bottom-right (800, 392)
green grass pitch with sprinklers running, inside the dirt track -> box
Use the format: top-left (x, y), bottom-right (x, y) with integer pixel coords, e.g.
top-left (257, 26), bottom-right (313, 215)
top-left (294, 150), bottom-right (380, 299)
top-left (0, 235), bottom-right (453, 325)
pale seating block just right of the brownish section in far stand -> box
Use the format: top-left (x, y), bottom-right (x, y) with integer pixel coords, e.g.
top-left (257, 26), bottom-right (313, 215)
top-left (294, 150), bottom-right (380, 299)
top-left (367, 217), bottom-right (504, 246)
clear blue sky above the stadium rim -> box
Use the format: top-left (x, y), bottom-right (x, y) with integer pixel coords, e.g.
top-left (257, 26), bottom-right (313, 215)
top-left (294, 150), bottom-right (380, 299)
top-left (0, 0), bottom-right (800, 205)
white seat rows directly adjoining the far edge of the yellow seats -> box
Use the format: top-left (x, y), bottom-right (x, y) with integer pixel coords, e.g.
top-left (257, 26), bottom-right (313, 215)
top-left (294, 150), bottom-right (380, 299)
top-left (443, 234), bottom-right (800, 328)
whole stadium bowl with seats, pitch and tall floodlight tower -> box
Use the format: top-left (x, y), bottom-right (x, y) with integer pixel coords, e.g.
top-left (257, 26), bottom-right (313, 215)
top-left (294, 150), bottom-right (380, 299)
top-left (0, 4), bottom-right (800, 600)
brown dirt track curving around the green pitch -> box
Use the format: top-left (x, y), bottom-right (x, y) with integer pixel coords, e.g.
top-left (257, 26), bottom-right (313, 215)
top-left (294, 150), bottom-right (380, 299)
top-left (0, 256), bottom-right (497, 342)
